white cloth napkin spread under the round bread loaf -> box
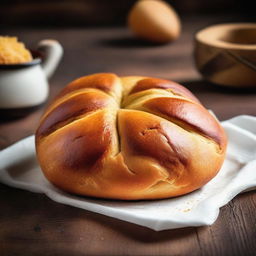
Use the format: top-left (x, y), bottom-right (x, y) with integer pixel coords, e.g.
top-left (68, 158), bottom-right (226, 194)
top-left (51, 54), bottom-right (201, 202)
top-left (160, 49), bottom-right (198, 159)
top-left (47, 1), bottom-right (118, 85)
top-left (0, 116), bottom-right (256, 231)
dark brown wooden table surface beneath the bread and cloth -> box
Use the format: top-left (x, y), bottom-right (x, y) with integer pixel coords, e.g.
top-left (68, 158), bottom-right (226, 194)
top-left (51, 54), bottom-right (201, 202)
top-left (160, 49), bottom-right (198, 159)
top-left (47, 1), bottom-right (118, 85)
top-left (0, 18), bottom-right (256, 256)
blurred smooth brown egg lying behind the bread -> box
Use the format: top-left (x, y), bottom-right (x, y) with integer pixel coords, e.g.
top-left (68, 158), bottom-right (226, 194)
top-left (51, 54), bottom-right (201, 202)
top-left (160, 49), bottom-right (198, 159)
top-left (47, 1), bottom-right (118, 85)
top-left (128, 0), bottom-right (181, 43)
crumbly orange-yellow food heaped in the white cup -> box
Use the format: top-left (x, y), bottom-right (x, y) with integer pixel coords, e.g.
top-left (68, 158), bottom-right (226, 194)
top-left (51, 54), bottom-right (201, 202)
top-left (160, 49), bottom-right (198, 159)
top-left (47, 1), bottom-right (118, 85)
top-left (0, 36), bottom-right (33, 64)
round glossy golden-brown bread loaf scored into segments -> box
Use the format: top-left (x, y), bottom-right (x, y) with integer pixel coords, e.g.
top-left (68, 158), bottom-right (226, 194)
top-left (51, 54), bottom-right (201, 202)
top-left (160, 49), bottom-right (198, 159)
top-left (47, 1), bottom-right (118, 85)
top-left (36, 73), bottom-right (227, 200)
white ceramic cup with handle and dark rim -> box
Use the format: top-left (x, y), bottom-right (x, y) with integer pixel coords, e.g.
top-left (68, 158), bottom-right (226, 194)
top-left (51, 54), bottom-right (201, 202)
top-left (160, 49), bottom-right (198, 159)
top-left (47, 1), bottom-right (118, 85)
top-left (0, 40), bottom-right (63, 110)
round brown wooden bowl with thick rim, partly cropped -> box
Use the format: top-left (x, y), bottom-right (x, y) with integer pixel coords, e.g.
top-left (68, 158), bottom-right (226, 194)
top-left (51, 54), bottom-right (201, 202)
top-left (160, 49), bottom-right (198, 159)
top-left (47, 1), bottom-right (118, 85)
top-left (194, 23), bottom-right (256, 87)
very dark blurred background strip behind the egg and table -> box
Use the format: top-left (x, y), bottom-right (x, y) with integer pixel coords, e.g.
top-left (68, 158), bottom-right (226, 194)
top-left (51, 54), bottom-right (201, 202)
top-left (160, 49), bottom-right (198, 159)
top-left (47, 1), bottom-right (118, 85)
top-left (0, 0), bottom-right (255, 27)
